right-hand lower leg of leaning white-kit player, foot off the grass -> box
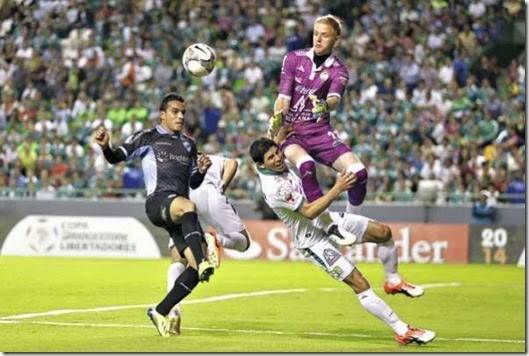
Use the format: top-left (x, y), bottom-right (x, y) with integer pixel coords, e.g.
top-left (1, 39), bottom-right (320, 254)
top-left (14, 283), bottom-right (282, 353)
top-left (362, 220), bottom-right (424, 298)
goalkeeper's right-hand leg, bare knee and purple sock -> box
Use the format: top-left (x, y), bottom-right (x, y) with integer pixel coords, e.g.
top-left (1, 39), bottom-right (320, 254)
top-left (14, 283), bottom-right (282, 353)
top-left (332, 151), bottom-right (367, 213)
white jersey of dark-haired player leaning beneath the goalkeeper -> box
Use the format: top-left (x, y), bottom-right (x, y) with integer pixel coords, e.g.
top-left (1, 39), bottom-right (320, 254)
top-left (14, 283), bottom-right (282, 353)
top-left (257, 169), bottom-right (327, 248)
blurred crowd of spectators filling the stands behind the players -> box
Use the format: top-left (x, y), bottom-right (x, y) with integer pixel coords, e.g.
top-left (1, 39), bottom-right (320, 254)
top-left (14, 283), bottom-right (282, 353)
top-left (0, 0), bottom-right (526, 206)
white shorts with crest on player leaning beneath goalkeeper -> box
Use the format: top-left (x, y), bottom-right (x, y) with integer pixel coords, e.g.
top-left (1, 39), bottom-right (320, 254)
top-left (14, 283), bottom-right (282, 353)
top-left (299, 239), bottom-right (355, 281)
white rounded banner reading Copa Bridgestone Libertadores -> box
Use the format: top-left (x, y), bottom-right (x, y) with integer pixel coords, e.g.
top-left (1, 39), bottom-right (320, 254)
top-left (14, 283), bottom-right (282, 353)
top-left (0, 215), bottom-right (161, 258)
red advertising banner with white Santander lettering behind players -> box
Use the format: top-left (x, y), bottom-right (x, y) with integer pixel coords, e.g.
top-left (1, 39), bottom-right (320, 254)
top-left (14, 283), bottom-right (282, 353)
top-left (218, 220), bottom-right (469, 263)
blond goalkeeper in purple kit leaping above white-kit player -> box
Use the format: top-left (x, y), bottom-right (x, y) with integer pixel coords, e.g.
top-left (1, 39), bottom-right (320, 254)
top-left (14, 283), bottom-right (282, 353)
top-left (268, 15), bottom-right (367, 212)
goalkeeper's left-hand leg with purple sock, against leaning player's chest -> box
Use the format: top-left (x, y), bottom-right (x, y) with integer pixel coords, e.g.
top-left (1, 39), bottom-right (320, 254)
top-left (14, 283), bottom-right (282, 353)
top-left (284, 144), bottom-right (323, 202)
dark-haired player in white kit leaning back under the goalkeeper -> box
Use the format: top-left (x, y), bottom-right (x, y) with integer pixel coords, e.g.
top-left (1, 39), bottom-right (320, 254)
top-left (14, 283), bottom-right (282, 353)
top-left (250, 127), bottom-right (435, 344)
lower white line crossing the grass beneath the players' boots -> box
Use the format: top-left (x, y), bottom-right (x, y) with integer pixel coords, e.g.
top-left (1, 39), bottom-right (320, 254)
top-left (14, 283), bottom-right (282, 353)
top-left (0, 320), bottom-right (525, 344)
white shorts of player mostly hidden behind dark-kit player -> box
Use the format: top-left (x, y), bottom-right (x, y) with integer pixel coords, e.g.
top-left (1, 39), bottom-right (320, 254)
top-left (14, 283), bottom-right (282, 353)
top-left (169, 183), bottom-right (246, 248)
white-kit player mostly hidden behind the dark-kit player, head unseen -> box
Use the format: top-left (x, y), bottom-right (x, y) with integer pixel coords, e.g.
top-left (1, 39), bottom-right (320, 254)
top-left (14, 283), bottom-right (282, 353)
top-left (167, 155), bottom-right (251, 335)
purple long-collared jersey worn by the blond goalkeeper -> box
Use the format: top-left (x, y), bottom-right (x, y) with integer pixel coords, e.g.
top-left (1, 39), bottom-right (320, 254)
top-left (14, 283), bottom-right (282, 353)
top-left (279, 48), bottom-right (349, 135)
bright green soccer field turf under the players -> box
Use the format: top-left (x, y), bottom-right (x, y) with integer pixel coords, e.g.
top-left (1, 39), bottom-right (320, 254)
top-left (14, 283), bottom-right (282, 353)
top-left (0, 257), bottom-right (526, 352)
